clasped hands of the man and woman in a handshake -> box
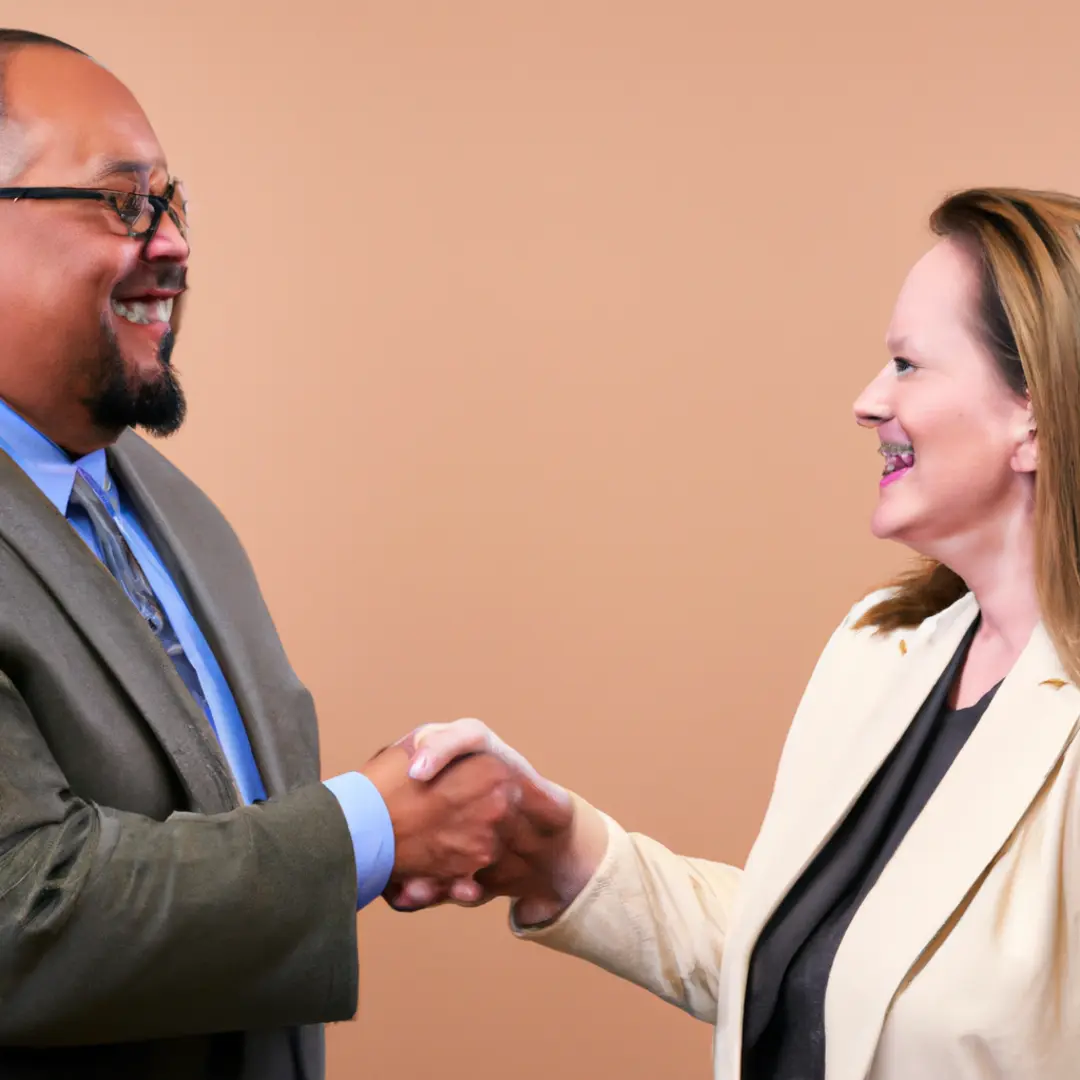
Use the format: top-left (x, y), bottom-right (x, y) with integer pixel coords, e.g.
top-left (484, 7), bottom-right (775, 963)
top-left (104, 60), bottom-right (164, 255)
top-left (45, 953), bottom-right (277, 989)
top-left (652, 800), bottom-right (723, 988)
top-left (364, 719), bottom-right (607, 924)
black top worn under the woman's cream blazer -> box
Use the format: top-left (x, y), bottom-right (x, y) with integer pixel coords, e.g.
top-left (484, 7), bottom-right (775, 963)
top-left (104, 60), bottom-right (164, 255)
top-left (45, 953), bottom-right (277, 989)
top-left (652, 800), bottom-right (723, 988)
top-left (743, 622), bottom-right (997, 1080)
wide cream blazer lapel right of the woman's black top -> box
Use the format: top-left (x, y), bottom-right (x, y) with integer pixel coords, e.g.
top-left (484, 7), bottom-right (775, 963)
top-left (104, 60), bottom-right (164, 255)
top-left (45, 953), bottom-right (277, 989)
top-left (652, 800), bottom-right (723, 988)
top-left (825, 625), bottom-right (1080, 1080)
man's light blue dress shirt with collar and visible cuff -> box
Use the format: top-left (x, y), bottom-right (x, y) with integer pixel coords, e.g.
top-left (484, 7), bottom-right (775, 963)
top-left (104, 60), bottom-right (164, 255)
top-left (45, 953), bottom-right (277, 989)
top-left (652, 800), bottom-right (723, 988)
top-left (0, 400), bottom-right (394, 909)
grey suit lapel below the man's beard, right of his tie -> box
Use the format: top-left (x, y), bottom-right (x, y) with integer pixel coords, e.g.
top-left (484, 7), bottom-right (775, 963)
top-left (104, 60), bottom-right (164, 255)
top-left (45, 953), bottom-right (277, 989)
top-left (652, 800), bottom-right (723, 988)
top-left (109, 433), bottom-right (292, 797)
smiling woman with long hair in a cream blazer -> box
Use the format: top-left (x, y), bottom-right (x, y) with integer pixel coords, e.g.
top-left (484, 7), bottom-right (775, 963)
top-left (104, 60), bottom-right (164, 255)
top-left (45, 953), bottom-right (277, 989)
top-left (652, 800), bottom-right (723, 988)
top-left (397, 189), bottom-right (1080, 1080)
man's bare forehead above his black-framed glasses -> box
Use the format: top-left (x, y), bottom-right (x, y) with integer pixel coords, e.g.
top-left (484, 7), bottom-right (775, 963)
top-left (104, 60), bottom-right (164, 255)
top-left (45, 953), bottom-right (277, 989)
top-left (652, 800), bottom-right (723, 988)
top-left (4, 46), bottom-right (165, 184)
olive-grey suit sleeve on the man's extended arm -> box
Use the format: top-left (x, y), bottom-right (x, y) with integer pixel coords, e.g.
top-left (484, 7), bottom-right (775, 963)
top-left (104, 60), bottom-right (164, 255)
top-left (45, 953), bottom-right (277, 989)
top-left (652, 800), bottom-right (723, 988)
top-left (0, 675), bottom-right (357, 1047)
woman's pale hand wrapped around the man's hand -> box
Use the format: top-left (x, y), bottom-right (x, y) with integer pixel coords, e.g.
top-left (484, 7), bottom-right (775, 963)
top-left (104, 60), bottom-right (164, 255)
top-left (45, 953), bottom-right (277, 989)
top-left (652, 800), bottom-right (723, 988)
top-left (384, 719), bottom-right (607, 923)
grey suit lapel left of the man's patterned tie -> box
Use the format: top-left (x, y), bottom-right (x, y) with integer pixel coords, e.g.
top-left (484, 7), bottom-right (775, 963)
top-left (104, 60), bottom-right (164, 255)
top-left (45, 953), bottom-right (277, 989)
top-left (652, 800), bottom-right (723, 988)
top-left (0, 453), bottom-right (235, 812)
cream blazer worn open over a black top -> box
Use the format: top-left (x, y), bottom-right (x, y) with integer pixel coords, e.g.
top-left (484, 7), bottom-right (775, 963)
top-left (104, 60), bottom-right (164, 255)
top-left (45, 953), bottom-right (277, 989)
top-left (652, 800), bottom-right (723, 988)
top-left (513, 593), bottom-right (1080, 1080)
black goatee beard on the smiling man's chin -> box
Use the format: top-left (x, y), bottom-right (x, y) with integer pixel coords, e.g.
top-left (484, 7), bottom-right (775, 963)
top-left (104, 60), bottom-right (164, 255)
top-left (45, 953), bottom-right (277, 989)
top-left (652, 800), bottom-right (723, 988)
top-left (86, 319), bottom-right (188, 437)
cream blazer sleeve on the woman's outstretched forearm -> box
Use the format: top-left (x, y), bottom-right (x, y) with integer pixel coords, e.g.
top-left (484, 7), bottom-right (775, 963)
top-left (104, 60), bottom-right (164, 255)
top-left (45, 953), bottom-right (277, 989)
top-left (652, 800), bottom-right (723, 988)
top-left (511, 799), bottom-right (742, 1023)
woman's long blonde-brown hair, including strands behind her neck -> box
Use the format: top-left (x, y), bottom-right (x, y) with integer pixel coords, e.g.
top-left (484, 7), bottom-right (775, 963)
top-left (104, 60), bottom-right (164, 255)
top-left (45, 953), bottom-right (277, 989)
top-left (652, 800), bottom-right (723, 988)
top-left (859, 182), bottom-right (1080, 684)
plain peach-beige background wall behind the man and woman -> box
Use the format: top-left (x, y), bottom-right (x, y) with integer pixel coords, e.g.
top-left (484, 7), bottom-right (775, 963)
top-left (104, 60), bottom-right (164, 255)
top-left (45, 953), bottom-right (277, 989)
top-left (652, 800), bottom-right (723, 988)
top-left (0, 0), bottom-right (1080, 1080)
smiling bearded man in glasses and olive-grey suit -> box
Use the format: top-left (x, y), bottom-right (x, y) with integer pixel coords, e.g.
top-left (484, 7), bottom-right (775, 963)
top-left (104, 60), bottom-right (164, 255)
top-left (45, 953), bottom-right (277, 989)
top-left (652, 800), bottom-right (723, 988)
top-left (0, 30), bottom-right (569, 1080)
